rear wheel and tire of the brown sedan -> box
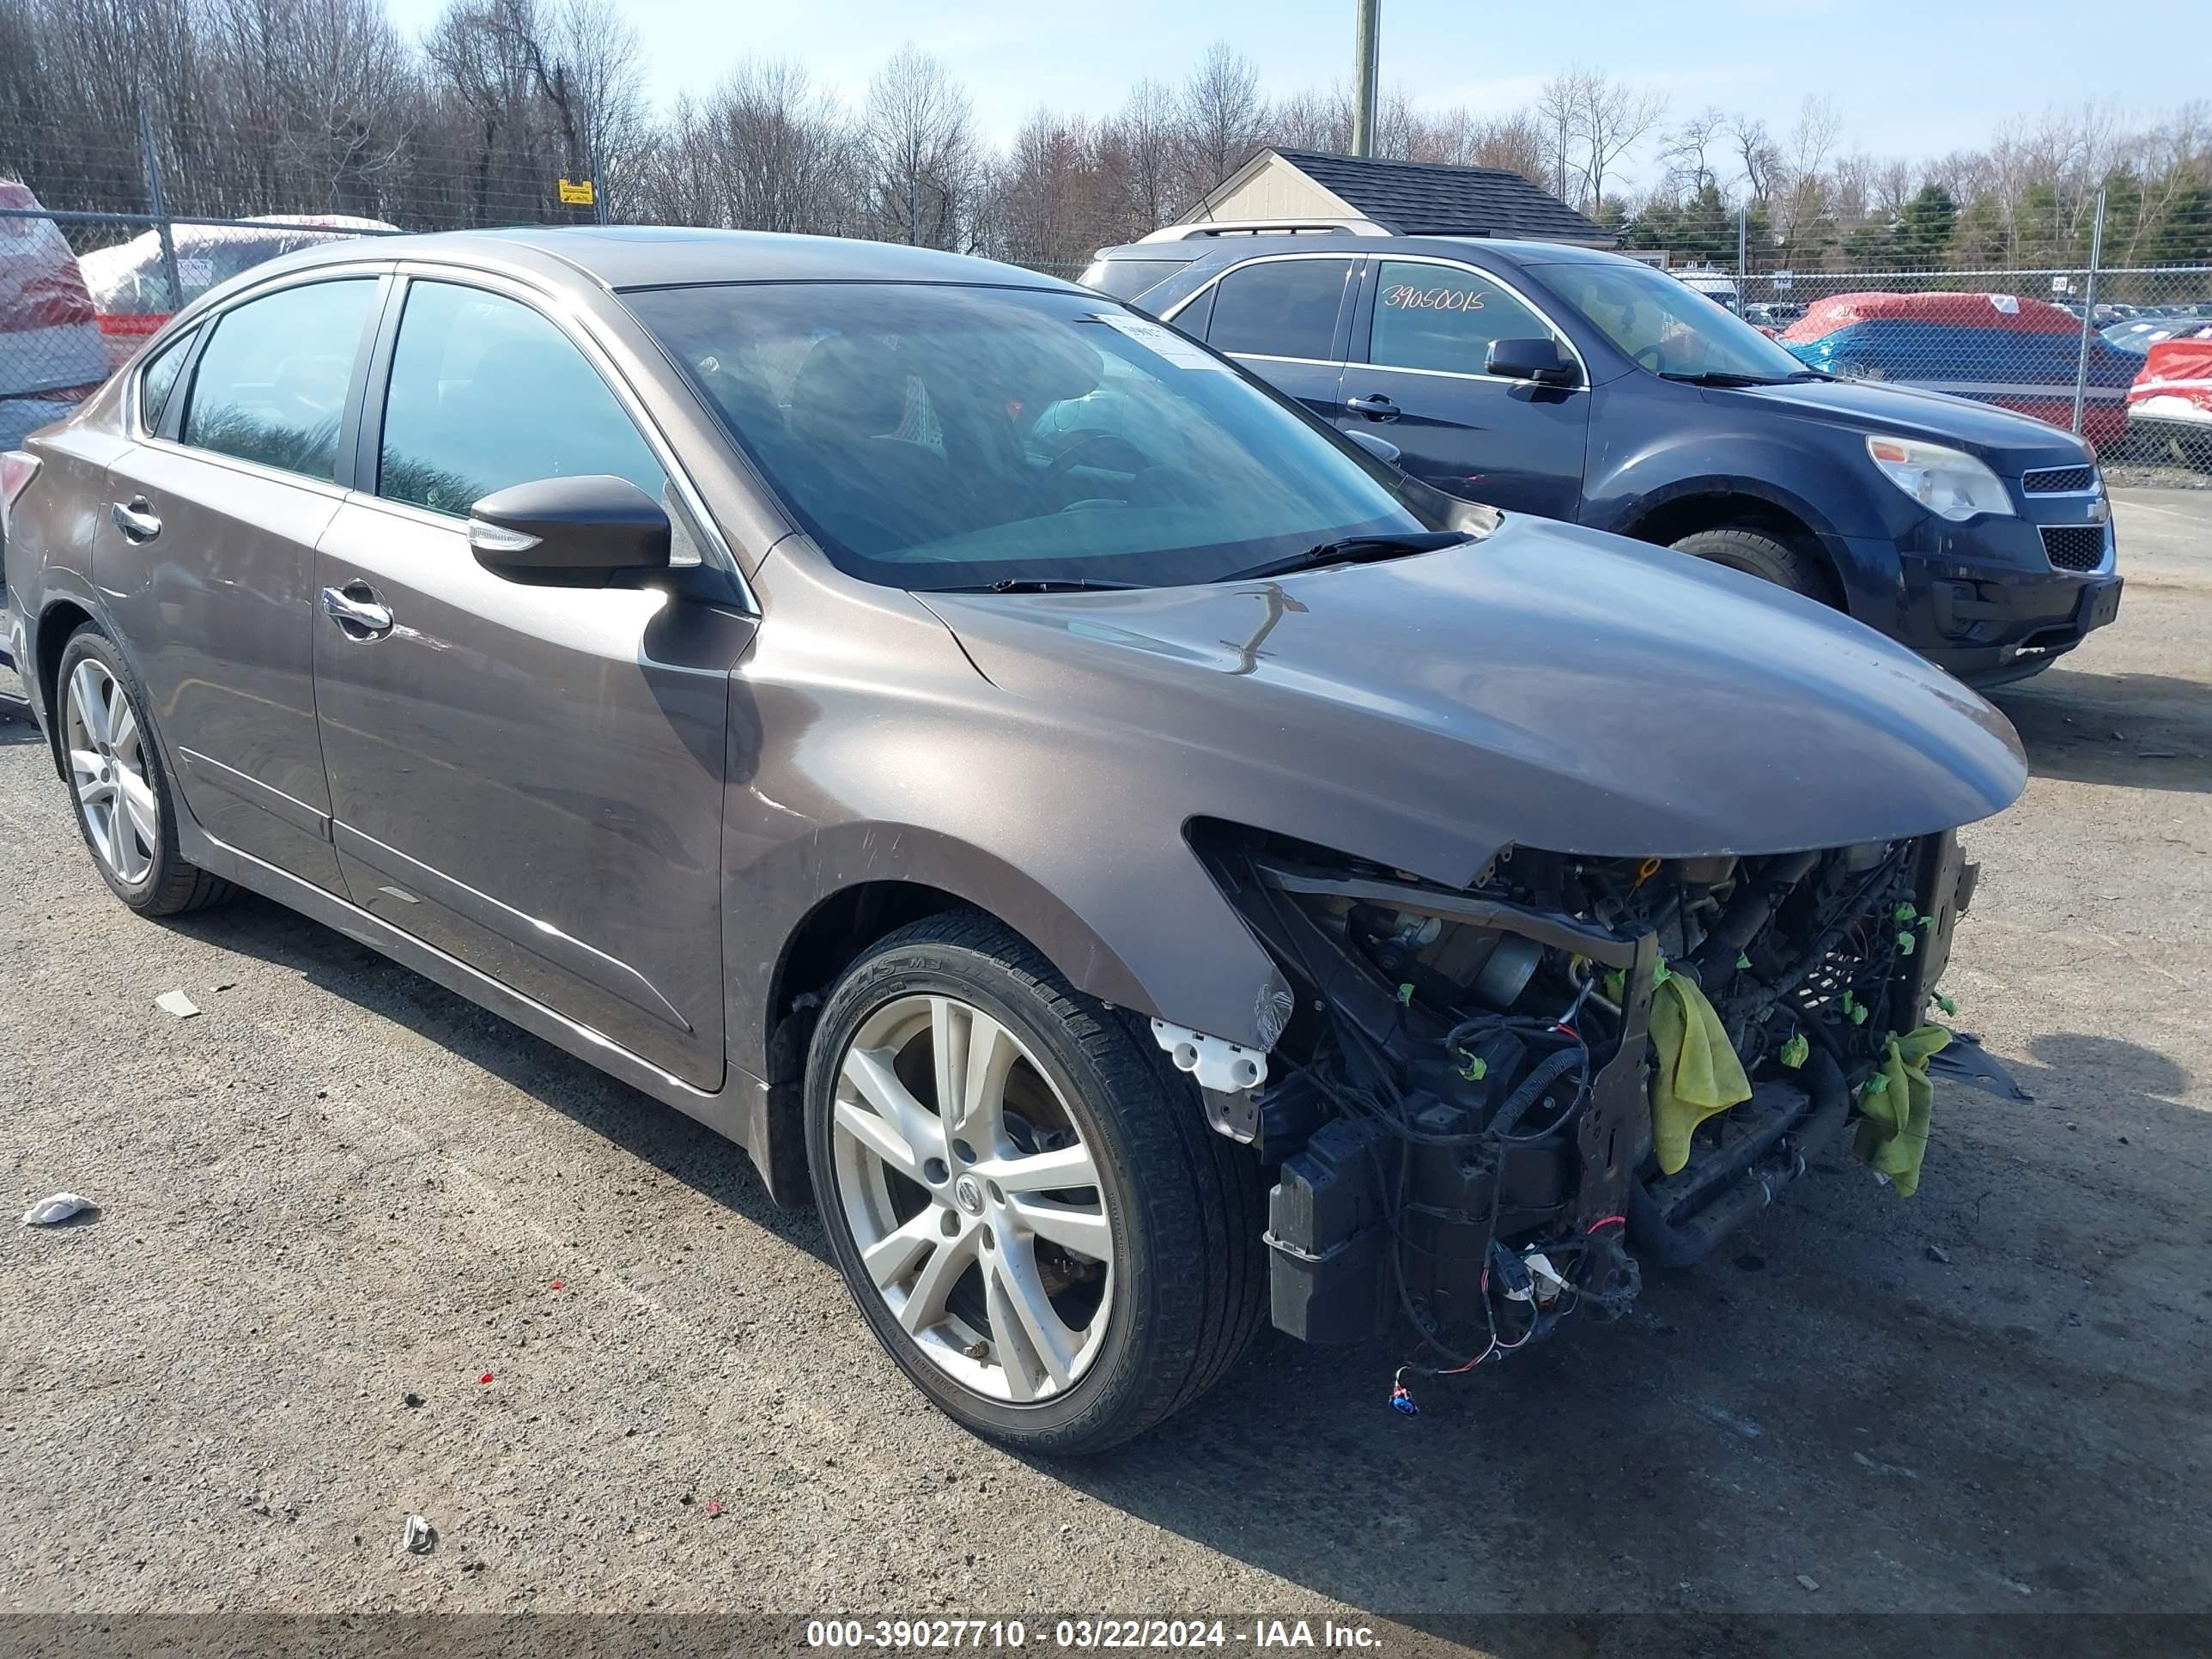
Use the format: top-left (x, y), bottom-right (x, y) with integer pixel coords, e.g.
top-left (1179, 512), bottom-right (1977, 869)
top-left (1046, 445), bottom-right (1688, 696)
top-left (53, 622), bottom-right (232, 915)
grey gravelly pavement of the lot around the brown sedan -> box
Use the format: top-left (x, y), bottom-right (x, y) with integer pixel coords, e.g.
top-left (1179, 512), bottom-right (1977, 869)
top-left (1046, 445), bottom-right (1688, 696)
top-left (0, 491), bottom-right (2212, 1652)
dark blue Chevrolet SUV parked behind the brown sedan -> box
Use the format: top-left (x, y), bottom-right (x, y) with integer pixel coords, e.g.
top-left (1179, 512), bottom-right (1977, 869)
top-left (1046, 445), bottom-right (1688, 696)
top-left (1091, 234), bottom-right (2119, 686)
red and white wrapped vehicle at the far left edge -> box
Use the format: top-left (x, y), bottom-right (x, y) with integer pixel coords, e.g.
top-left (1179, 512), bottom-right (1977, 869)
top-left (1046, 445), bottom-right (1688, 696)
top-left (0, 179), bottom-right (108, 449)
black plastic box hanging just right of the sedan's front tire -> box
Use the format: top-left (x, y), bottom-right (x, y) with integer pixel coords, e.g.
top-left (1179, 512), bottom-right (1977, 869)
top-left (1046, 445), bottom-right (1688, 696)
top-left (1267, 1117), bottom-right (1398, 1343)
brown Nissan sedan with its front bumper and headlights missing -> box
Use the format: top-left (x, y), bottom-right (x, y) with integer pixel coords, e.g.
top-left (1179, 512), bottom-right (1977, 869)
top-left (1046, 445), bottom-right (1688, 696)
top-left (0, 230), bottom-right (2024, 1451)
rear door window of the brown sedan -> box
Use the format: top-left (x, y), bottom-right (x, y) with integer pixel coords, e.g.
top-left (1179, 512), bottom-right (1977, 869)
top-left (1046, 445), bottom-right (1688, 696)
top-left (184, 276), bottom-right (376, 480)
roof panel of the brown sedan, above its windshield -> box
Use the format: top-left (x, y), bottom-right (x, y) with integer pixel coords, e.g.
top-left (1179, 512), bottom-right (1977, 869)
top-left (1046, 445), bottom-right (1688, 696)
top-left (261, 226), bottom-right (1088, 295)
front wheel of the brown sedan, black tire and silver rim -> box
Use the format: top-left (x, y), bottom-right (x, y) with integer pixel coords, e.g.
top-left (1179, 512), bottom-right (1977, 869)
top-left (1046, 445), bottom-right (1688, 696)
top-left (805, 911), bottom-right (1265, 1453)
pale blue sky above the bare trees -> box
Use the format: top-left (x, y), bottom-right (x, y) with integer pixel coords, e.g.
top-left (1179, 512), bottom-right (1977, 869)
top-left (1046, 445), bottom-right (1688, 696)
top-left (392, 0), bottom-right (2205, 185)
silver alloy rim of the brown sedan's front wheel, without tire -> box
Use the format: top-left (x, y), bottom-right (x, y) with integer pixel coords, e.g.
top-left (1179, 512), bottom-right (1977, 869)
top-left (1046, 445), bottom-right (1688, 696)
top-left (832, 995), bottom-right (1115, 1402)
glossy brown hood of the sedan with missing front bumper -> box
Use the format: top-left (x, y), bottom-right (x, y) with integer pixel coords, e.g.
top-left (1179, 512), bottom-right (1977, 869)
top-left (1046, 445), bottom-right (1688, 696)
top-left (927, 515), bottom-right (2027, 883)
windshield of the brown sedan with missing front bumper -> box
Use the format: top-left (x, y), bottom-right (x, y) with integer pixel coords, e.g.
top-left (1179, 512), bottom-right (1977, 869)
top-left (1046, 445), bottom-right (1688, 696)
top-left (623, 283), bottom-right (1427, 592)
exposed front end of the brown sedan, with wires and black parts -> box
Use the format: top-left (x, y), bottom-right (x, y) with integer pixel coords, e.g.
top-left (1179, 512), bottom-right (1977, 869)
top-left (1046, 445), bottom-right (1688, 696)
top-left (1192, 825), bottom-right (1975, 1380)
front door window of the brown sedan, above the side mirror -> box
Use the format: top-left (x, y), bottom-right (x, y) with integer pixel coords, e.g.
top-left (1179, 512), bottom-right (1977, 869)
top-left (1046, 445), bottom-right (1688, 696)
top-left (376, 283), bottom-right (668, 518)
